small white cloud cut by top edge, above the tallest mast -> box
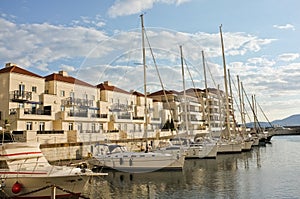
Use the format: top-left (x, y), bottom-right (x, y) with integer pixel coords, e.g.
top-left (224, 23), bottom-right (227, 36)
top-left (108, 0), bottom-right (190, 17)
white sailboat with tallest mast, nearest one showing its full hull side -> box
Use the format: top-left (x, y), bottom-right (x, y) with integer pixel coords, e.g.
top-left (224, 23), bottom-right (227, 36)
top-left (89, 15), bottom-right (185, 173)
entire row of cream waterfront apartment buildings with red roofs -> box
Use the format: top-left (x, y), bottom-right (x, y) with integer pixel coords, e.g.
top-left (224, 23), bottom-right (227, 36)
top-left (0, 63), bottom-right (234, 144)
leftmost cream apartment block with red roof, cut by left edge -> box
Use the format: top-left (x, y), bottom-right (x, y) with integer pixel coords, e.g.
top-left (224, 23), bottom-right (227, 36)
top-left (0, 63), bottom-right (57, 141)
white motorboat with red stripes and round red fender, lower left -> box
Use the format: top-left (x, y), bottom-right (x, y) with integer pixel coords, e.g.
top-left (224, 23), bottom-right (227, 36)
top-left (0, 130), bottom-right (107, 198)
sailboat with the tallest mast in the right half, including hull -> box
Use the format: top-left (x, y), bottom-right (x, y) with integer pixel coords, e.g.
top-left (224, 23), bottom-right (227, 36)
top-left (218, 25), bottom-right (242, 153)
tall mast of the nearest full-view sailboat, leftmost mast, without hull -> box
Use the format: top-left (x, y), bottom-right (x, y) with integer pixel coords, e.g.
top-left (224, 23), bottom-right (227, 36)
top-left (140, 14), bottom-right (148, 151)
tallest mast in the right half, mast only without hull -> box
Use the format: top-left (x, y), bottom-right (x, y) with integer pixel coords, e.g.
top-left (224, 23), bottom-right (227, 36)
top-left (220, 25), bottom-right (230, 136)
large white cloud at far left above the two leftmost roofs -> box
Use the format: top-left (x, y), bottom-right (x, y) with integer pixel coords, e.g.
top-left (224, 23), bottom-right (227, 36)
top-left (0, 18), bottom-right (107, 71)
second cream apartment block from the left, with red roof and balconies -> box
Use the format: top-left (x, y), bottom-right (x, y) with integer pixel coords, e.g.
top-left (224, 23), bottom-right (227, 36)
top-left (45, 71), bottom-right (108, 142)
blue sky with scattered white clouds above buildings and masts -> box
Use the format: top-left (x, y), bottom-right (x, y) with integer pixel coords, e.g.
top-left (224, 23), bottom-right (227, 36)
top-left (0, 0), bottom-right (300, 121)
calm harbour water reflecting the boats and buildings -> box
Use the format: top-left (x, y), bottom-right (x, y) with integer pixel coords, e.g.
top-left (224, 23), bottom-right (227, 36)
top-left (84, 136), bottom-right (300, 199)
